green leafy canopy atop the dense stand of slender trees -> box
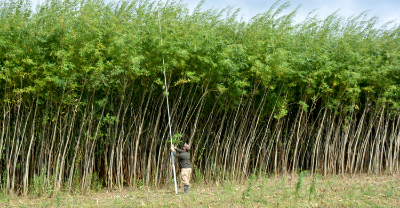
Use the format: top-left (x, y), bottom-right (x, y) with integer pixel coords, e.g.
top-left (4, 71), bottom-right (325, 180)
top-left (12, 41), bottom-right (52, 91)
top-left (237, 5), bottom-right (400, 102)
top-left (0, 0), bottom-right (400, 112)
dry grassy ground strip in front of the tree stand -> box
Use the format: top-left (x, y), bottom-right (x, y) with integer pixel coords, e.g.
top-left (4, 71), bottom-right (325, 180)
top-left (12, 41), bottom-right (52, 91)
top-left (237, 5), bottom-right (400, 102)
top-left (0, 174), bottom-right (400, 207)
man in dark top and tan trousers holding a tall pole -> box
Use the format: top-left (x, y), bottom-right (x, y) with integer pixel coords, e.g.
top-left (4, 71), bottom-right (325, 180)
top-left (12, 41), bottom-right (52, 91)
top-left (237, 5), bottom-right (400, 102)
top-left (171, 143), bottom-right (192, 194)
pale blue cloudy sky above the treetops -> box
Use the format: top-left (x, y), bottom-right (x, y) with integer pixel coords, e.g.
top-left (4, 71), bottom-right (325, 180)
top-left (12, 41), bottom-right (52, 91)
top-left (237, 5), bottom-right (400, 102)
top-left (32, 0), bottom-right (400, 26)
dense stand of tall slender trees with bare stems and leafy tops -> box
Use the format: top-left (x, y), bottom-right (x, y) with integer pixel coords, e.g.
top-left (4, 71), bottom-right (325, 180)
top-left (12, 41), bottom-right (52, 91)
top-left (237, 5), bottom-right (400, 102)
top-left (0, 0), bottom-right (400, 195)
